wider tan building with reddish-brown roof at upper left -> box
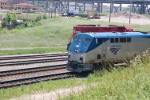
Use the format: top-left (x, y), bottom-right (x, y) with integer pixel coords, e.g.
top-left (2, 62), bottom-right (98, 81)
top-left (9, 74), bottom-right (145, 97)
top-left (12, 3), bottom-right (42, 10)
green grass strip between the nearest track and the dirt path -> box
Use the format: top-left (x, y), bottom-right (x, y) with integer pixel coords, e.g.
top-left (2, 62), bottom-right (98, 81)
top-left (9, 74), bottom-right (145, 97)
top-left (0, 79), bottom-right (82, 100)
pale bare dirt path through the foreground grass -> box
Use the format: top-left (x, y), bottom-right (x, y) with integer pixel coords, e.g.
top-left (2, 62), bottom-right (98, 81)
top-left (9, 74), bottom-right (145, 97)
top-left (7, 86), bottom-right (88, 100)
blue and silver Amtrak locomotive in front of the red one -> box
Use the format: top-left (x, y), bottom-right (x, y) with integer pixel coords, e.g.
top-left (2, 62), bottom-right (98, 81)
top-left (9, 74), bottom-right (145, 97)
top-left (67, 32), bottom-right (150, 73)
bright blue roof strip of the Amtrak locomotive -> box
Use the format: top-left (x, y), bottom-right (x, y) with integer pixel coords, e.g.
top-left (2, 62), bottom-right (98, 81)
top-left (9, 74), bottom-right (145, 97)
top-left (77, 32), bottom-right (150, 38)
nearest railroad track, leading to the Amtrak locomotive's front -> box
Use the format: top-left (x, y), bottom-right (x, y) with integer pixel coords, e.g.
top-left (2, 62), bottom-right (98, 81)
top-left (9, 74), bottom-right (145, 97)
top-left (0, 72), bottom-right (73, 89)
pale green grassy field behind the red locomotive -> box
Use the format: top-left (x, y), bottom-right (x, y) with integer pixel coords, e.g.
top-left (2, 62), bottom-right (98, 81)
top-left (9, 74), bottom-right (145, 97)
top-left (0, 17), bottom-right (150, 54)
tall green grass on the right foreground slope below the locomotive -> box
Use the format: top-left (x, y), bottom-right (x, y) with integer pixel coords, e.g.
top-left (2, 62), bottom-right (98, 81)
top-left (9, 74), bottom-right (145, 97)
top-left (60, 64), bottom-right (150, 100)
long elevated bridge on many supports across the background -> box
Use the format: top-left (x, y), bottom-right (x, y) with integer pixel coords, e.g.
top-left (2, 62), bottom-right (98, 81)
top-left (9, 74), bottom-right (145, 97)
top-left (26, 0), bottom-right (150, 14)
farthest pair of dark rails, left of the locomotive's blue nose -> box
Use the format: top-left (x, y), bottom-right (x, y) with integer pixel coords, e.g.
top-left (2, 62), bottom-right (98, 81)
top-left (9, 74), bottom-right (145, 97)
top-left (0, 53), bottom-right (67, 67)
